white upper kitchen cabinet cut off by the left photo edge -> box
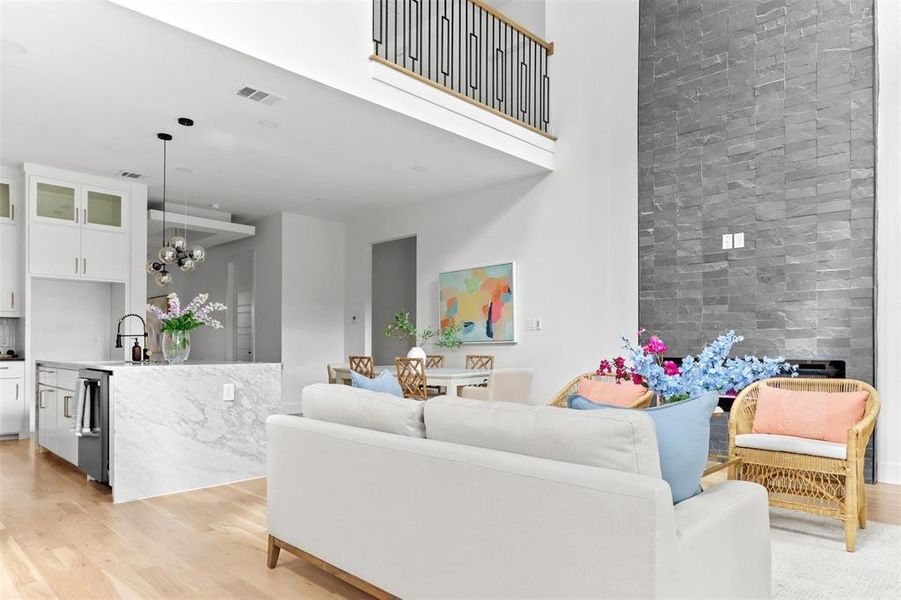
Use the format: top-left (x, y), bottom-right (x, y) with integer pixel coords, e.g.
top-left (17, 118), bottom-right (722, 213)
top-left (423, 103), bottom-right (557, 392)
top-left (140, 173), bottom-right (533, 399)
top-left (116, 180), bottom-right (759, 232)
top-left (0, 177), bottom-right (22, 317)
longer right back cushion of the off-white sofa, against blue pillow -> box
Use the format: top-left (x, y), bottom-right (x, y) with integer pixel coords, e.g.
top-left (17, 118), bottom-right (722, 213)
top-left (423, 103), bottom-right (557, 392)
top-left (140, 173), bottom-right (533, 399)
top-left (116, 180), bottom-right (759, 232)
top-left (425, 396), bottom-right (660, 477)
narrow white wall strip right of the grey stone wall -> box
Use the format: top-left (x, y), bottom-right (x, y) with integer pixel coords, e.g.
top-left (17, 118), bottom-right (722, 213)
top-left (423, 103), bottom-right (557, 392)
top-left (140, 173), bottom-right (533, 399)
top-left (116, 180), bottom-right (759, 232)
top-left (876, 0), bottom-right (901, 483)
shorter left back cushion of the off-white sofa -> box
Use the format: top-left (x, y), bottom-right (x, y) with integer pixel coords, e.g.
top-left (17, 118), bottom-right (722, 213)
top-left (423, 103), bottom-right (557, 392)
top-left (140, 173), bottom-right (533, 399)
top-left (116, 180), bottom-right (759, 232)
top-left (301, 383), bottom-right (425, 438)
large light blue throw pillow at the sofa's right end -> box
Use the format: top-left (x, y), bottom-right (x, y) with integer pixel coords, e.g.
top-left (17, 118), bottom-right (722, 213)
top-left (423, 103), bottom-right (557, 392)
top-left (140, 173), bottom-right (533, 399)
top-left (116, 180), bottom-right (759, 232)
top-left (567, 392), bottom-right (719, 504)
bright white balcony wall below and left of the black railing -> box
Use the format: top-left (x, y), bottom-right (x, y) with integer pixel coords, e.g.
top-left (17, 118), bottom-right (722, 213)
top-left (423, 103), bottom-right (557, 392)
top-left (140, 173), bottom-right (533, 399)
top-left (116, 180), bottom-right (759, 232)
top-left (111, 0), bottom-right (555, 170)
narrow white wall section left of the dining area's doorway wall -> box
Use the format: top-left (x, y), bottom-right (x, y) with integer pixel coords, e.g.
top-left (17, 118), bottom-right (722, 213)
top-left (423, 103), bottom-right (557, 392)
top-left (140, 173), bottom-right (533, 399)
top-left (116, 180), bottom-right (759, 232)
top-left (284, 213), bottom-right (346, 408)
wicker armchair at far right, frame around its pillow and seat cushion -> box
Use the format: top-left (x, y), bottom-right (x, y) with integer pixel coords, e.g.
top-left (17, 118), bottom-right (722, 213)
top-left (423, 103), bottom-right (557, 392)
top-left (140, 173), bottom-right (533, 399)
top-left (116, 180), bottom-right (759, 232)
top-left (729, 377), bottom-right (879, 552)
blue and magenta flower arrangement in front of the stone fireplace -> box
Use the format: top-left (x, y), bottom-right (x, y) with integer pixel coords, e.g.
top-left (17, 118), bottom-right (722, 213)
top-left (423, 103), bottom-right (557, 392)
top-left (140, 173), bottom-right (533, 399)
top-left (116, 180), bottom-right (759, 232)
top-left (622, 330), bottom-right (798, 403)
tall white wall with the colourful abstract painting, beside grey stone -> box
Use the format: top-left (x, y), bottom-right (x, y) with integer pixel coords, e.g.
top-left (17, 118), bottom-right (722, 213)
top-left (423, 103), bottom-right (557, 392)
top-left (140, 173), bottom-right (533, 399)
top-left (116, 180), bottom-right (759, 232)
top-left (345, 0), bottom-right (638, 403)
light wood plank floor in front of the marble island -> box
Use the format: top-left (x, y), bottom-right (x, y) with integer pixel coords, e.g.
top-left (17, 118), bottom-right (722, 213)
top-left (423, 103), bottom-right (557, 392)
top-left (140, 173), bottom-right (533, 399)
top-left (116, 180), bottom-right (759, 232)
top-left (0, 441), bottom-right (901, 600)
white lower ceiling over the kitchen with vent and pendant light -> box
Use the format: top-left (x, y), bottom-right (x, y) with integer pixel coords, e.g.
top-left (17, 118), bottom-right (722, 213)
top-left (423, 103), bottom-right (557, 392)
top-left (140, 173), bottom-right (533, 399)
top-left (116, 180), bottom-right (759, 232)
top-left (0, 2), bottom-right (543, 221)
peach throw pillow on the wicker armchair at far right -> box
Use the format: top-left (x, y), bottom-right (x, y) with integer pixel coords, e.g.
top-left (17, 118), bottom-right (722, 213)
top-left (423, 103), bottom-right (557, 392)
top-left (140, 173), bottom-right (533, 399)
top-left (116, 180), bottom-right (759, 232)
top-left (752, 385), bottom-right (869, 443)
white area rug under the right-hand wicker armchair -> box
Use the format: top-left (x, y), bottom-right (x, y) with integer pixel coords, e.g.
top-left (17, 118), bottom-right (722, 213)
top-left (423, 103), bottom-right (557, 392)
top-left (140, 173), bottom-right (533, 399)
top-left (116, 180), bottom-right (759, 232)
top-left (770, 508), bottom-right (901, 600)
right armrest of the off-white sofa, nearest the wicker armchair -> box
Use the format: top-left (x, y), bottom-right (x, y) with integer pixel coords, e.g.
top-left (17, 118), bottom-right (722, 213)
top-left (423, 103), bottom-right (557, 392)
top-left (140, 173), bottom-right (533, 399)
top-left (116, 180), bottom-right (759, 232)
top-left (673, 481), bottom-right (771, 598)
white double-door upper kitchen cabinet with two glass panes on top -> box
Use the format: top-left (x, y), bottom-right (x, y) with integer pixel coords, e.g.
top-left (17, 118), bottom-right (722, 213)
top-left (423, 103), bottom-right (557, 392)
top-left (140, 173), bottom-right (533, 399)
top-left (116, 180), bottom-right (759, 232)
top-left (28, 175), bottom-right (130, 281)
